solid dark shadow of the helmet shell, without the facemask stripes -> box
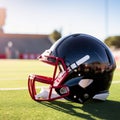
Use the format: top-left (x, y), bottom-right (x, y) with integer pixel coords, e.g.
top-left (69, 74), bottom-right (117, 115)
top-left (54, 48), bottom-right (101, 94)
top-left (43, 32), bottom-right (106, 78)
top-left (81, 100), bottom-right (120, 120)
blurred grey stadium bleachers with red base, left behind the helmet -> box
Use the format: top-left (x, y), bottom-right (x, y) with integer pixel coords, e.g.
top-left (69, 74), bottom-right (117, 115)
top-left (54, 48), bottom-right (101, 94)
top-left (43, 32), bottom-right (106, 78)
top-left (0, 34), bottom-right (52, 59)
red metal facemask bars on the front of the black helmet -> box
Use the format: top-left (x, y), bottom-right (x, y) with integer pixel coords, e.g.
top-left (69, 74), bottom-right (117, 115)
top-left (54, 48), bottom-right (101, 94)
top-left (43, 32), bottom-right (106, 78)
top-left (28, 54), bottom-right (69, 101)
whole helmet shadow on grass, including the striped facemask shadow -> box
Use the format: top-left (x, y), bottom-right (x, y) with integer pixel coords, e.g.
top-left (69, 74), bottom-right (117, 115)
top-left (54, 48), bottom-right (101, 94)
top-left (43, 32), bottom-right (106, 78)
top-left (40, 100), bottom-right (120, 120)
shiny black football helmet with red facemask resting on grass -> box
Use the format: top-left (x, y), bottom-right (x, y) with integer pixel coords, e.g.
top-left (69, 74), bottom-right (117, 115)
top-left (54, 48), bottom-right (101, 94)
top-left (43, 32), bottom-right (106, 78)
top-left (28, 34), bottom-right (116, 103)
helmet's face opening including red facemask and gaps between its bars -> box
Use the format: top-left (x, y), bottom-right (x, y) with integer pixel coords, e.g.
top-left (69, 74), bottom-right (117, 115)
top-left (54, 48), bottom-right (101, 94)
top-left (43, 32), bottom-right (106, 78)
top-left (28, 54), bottom-right (69, 101)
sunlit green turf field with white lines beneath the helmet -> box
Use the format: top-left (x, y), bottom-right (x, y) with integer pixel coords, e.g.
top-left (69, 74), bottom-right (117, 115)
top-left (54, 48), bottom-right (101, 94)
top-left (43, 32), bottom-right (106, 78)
top-left (0, 60), bottom-right (120, 120)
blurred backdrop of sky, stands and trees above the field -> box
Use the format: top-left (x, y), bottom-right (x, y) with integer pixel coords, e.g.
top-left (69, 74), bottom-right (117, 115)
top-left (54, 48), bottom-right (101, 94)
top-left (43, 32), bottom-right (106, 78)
top-left (0, 0), bottom-right (120, 60)
